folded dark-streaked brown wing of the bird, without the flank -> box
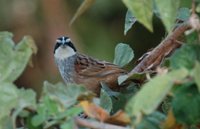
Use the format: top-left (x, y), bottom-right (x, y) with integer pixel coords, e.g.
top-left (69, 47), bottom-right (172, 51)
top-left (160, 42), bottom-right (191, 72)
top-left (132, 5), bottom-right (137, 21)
top-left (75, 54), bottom-right (126, 78)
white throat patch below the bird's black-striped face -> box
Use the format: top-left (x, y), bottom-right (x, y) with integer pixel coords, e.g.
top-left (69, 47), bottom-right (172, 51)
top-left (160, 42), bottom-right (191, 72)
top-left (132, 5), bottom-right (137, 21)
top-left (54, 46), bottom-right (76, 59)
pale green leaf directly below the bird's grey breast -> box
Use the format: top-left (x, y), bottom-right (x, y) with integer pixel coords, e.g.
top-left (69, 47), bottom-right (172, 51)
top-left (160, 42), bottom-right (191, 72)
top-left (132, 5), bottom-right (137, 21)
top-left (43, 82), bottom-right (86, 108)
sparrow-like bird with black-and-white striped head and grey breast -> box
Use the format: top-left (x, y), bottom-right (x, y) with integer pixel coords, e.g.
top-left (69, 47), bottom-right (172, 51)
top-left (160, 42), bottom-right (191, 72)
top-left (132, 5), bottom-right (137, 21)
top-left (54, 36), bottom-right (127, 95)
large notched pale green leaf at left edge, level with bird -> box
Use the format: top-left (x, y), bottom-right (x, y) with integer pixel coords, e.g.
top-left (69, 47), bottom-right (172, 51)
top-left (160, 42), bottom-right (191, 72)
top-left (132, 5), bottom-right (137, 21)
top-left (0, 32), bottom-right (34, 82)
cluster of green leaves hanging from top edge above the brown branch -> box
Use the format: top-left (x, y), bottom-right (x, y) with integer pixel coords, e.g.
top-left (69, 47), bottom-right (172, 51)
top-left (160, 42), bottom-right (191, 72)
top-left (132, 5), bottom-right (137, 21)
top-left (123, 0), bottom-right (191, 32)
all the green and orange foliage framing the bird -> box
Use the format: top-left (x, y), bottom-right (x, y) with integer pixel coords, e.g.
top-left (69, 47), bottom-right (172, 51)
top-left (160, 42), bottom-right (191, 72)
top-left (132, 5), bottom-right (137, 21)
top-left (0, 0), bottom-right (200, 129)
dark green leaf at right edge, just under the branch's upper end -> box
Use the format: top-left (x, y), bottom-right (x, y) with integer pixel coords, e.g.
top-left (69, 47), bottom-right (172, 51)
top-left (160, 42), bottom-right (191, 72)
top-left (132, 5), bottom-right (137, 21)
top-left (170, 44), bottom-right (200, 69)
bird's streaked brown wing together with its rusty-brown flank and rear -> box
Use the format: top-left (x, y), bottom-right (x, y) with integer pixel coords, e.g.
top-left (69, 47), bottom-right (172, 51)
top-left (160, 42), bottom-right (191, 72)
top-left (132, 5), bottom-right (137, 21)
top-left (74, 54), bottom-right (126, 95)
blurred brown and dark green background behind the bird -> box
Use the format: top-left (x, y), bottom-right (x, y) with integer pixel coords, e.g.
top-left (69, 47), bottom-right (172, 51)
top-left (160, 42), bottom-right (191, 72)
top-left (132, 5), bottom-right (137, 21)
top-left (0, 0), bottom-right (165, 92)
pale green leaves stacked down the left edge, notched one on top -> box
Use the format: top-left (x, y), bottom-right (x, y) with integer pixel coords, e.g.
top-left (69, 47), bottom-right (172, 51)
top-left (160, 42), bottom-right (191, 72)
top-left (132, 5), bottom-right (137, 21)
top-left (0, 32), bottom-right (36, 129)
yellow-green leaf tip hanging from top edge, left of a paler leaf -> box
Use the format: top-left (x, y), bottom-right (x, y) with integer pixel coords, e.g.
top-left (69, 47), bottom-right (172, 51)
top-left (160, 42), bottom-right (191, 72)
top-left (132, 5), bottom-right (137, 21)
top-left (122, 0), bottom-right (153, 31)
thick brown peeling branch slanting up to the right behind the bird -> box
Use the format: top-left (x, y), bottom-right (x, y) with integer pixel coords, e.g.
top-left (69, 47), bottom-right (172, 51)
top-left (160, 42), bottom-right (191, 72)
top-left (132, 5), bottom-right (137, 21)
top-left (128, 22), bottom-right (191, 76)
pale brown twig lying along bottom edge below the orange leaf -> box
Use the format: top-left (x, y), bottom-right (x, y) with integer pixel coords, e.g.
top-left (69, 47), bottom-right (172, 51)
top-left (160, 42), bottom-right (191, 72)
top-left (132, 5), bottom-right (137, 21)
top-left (75, 117), bottom-right (133, 129)
